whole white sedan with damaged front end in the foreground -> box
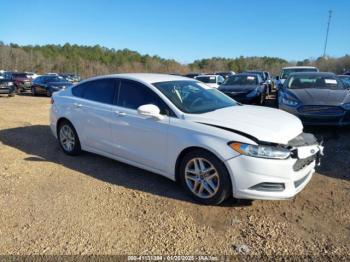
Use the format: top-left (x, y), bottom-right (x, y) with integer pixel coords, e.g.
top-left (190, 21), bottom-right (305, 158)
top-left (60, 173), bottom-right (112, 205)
top-left (50, 74), bottom-right (322, 204)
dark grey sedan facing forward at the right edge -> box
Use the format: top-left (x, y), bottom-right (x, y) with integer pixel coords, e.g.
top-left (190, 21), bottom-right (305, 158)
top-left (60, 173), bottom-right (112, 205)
top-left (278, 72), bottom-right (350, 125)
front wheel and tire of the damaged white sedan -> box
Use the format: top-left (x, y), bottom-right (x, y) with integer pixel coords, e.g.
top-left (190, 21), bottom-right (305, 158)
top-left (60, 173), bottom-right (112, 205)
top-left (179, 149), bottom-right (232, 205)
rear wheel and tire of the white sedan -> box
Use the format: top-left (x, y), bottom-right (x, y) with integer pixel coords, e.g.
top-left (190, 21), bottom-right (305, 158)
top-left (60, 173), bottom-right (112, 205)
top-left (57, 120), bottom-right (81, 156)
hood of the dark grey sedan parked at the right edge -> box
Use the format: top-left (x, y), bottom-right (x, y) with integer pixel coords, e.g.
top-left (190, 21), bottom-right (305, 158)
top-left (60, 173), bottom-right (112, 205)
top-left (288, 88), bottom-right (350, 106)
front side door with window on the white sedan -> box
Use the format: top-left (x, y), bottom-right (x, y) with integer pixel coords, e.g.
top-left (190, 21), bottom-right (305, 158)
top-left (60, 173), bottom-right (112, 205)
top-left (111, 79), bottom-right (170, 170)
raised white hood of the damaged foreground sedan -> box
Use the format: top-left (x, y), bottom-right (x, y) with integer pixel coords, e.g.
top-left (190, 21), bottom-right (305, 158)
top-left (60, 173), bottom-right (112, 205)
top-left (185, 105), bottom-right (303, 145)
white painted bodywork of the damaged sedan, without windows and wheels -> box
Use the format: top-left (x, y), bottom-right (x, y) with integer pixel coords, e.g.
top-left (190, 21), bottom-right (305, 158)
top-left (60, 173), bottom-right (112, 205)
top-left (50, 74), bottom-right (320, 199)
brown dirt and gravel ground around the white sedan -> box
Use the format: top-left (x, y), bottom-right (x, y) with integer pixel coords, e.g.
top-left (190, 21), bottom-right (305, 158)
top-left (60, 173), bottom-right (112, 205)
top-left (0, 96), bottom-right (350, 256)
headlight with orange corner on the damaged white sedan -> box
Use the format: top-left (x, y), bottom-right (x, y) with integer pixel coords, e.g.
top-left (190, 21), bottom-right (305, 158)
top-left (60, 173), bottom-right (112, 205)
top-left (229, 142), bottom-right (290, 159)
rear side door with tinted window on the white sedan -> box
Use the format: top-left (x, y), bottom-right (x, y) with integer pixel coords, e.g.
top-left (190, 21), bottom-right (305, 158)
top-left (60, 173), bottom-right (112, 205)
top-left (72, 78), bottom-right (117, 153)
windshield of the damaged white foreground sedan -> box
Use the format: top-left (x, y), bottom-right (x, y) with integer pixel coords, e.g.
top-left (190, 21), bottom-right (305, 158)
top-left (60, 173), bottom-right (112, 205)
top-left (153, 81), bottom-right (237, 114)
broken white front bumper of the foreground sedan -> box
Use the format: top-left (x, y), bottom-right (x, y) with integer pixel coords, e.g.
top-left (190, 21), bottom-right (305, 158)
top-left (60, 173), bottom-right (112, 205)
top-left (225, 133), bottom-right (323, 200)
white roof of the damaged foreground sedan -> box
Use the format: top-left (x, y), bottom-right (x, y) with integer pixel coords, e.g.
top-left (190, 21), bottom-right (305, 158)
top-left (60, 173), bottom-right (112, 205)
top-left (87, 73), bottom-right (195, 84)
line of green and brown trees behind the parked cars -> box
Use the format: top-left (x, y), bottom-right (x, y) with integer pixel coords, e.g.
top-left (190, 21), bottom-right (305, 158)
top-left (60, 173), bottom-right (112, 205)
top-left (0, 42), bottom-right (350, 78)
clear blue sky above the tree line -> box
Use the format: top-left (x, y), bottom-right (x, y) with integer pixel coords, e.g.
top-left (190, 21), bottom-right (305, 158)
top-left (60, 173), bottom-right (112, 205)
top-left (0, 0), bottom-right (350, 63)
